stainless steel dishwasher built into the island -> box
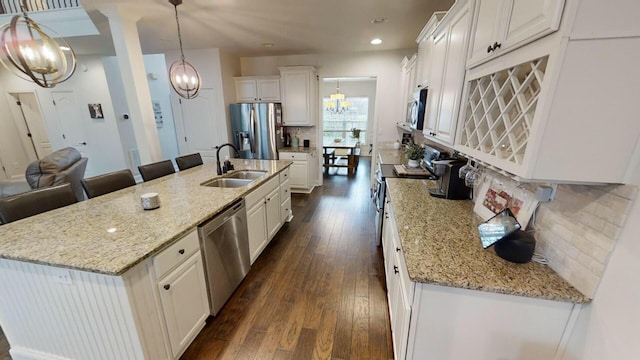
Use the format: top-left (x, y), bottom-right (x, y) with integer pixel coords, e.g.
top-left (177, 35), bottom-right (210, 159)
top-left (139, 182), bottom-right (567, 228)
top-left (198, 199), bottom-right (251, 315)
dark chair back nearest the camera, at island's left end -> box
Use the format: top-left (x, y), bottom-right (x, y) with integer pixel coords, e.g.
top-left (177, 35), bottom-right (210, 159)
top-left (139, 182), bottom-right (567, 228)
top-left (0, 183), bottom-right (78, 224)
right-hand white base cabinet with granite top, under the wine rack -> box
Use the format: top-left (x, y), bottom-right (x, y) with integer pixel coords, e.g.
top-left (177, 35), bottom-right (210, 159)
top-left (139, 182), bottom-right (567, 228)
top-left (383, 178), bottom-right (590, 360)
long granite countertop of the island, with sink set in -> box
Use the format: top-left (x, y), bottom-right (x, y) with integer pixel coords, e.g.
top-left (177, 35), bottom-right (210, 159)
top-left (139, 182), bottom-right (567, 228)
top-left (0, 159), bottom-right (291, 275)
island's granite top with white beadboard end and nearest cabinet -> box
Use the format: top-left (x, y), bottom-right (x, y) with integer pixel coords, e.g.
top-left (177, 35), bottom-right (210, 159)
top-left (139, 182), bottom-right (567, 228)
top-left (0, 159), bottom-right (291, 359)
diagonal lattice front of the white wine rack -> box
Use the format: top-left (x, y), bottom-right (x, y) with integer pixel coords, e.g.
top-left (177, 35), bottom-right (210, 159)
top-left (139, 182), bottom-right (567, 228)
top-left (461, 56), bottom-right (548, 164)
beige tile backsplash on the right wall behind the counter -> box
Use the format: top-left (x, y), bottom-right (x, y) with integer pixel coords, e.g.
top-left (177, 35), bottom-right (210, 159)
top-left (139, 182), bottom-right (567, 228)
top-left (476, 172), bottom-right (638, 297)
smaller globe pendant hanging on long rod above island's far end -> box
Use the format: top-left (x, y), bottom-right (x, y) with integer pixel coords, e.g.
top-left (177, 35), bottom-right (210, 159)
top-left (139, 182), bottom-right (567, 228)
top-left (169, 0), bottom-right (202, 99)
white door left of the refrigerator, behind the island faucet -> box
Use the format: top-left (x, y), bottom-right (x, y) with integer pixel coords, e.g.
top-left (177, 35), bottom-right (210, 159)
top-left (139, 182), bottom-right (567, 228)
top-left (174, 89), bottom-right (228, 162)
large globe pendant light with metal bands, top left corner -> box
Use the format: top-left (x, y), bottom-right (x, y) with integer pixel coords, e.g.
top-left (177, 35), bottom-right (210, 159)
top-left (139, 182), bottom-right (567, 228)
top-left (0, 0), bottom-right (76, 88)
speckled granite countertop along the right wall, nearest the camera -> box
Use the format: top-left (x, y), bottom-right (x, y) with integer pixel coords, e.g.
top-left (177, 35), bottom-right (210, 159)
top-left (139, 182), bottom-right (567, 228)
top-left (387, 178), bottom-right (590, 303)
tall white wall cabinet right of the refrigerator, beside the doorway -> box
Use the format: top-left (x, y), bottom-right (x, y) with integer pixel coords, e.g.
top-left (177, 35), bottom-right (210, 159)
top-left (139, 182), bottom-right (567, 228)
top-left (279, 66), bottom-right (319, 126)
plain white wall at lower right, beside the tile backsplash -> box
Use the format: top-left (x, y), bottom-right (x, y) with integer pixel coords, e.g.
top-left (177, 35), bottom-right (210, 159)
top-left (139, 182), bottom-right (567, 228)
top-left (564, 165), bottom-right (640, 360)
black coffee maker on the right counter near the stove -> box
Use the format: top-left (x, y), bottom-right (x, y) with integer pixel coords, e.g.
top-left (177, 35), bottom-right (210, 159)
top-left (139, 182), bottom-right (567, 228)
top-left (429, 159), bottom-right (471, 200)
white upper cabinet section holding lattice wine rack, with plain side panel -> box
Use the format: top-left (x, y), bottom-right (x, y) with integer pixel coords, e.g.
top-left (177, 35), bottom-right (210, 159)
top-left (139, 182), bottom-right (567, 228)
top-left (455, 3), bottom-right (640, 183)
